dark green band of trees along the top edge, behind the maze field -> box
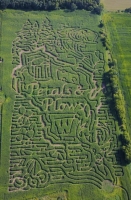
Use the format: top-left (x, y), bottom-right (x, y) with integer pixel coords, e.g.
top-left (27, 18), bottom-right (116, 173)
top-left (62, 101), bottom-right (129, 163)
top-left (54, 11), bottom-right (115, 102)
top-left (0, 0), bottom-right (103, 14)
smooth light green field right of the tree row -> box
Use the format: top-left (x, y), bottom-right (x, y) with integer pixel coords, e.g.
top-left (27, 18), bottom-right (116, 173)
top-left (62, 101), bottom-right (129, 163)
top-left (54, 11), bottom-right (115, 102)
top-left (103, 13), bottom-right (131, 198)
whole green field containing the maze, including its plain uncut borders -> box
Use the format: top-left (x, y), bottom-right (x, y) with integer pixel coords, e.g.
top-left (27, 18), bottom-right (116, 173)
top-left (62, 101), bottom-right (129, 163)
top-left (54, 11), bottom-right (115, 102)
top-left (0, 10), bottom-right (131, 200)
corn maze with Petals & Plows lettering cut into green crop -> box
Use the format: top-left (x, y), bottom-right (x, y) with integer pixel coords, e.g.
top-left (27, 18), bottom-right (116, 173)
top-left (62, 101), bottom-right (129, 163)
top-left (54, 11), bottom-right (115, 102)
top-left (9, 18), bottom-right (123, 192)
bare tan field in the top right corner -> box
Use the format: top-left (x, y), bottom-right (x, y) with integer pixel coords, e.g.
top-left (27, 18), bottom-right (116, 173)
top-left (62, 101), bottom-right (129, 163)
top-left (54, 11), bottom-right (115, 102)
top-left (101, 0), bottom-right (131, 11)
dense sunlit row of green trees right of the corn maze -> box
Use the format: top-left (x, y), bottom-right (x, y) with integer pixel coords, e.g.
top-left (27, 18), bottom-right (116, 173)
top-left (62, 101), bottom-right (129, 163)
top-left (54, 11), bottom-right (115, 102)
top-left (108, 68), bottom-right (131, 163)
